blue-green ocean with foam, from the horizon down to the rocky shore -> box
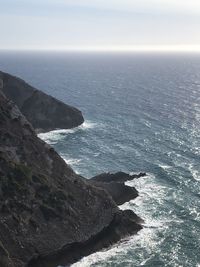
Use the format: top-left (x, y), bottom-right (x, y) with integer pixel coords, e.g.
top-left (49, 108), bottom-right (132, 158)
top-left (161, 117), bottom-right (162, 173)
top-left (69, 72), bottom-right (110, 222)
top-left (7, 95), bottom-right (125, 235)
top-left (0, 52), bottom-right (200, 267)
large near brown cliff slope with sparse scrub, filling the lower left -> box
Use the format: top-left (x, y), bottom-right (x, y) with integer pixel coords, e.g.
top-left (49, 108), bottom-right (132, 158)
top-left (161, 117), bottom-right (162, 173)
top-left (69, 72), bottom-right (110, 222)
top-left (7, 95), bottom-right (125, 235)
top-left (0, 90), bottom-right (141, 267)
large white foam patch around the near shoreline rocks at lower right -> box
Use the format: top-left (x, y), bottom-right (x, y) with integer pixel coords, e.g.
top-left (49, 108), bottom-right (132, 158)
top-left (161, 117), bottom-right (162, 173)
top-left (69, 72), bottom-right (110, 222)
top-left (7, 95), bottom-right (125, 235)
top-left (72, 174), bottom-right (171, 267)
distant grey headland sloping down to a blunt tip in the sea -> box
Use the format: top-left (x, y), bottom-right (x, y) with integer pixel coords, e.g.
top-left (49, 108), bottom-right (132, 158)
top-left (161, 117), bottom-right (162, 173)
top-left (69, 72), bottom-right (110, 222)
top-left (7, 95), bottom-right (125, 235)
top-left (0, 72), bottom-right (84, 132)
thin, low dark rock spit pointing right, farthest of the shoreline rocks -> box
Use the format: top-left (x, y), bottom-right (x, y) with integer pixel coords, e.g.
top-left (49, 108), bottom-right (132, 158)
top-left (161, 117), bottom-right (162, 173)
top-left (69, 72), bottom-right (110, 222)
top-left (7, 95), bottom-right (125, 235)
top-left (91, 172), bottom-right (146, 183)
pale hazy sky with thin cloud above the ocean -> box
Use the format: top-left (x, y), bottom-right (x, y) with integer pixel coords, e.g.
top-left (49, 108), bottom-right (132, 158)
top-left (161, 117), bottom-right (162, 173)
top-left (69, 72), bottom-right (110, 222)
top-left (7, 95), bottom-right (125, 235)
top-left (0, 0), bottom-right (200, 51)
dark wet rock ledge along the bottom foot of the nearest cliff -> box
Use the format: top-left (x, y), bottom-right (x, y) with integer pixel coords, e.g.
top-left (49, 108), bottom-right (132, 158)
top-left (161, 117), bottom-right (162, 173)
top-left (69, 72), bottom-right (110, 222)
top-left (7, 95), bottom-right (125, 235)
top-left (27, 210), bottom-right (143, 267)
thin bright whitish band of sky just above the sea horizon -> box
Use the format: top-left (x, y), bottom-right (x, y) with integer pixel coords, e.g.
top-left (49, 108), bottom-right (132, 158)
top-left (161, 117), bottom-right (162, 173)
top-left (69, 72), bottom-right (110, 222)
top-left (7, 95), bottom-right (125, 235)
top-left (0, 45), bottom-right (200, 53)
